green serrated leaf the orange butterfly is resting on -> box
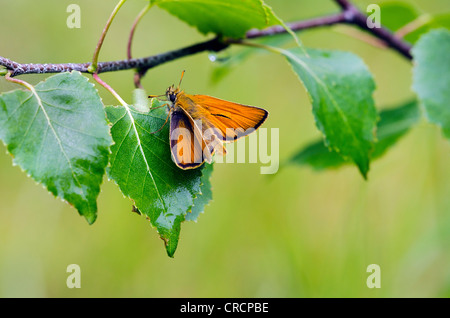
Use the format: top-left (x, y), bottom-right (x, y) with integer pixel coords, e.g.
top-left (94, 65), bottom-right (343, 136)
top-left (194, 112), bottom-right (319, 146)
top-left (106, 103), bottom-right (210, 257)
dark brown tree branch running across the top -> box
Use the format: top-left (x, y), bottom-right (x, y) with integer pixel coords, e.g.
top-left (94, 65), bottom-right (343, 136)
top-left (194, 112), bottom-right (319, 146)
top-left (0, 0), bottom-right (412, 77)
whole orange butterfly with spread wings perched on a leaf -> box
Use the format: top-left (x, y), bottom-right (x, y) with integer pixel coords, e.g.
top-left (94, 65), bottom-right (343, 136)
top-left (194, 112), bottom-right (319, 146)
top-left (148, 71), bottom-right (269, 169)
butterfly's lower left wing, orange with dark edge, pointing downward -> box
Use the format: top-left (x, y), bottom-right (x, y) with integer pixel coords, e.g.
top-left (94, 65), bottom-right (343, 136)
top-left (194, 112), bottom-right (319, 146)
top-left (170, 107), bottom-right (214, 170)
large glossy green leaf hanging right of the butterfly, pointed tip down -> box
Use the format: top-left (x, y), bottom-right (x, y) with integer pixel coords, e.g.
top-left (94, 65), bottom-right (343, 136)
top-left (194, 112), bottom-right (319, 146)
top-left (279, 48), bottom-right (378, 178)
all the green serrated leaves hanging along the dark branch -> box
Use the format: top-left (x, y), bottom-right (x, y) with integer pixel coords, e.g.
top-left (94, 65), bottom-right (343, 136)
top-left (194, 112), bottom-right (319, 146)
top-left (0, 0), bottom-right (450, 257)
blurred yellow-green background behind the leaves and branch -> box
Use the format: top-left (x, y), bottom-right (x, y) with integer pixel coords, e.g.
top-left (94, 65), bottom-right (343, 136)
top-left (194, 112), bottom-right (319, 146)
top-left (0, 0), bottom-right (450, 297)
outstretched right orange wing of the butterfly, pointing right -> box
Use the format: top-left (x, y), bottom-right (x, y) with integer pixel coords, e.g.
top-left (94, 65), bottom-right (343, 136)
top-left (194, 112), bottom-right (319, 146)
top-left (183, 94), bottom-right (269, 142)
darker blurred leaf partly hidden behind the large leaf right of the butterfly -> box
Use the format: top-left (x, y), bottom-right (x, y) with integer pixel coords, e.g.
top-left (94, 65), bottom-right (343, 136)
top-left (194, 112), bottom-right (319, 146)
top-left (289, 101), bottom-right (420, 170)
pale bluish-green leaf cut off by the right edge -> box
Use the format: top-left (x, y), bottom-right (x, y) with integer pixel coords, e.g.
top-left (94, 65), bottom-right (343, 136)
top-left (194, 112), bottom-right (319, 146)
top-left (412, 29), bottom-right (450, 139)
